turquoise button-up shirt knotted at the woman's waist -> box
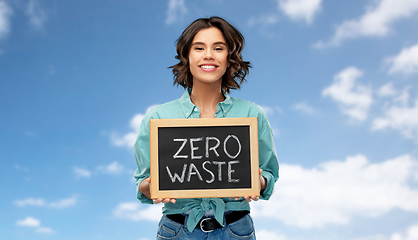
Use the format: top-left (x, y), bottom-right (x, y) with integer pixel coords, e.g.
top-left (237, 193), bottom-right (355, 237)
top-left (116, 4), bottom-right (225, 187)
top-left (134, 89), bottom-right (279, 232)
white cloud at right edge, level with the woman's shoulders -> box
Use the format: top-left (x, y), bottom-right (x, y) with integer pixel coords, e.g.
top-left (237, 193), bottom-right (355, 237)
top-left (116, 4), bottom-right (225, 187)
top-left (372, 88), bottom-right (418, 141)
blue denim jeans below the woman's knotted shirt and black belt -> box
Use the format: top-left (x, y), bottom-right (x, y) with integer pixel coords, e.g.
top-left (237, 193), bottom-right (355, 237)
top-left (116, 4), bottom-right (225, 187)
top-left (157, 214), bottom-right (256, 240)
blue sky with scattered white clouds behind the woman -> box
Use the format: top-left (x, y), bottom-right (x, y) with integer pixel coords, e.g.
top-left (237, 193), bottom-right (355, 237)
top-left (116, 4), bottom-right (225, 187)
top-left (0, 0), bottom-right (418, 240)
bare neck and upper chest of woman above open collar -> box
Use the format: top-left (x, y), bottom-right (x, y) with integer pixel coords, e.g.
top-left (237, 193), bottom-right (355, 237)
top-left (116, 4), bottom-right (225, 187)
top-left (190, 83), bottom-right (225, 118)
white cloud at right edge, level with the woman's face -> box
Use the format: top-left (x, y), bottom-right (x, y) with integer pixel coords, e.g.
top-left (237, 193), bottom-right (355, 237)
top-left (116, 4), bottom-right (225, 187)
top-left (386, 44), bottom-right (418, 74)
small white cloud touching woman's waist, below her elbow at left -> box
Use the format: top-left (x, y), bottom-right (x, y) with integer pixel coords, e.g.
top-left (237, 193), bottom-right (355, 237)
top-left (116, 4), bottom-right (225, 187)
top-left (113, 202), bottom-right (162, 221)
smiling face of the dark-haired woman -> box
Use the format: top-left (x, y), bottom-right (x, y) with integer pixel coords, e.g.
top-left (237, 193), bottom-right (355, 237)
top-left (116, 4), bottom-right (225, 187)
top-left (189, 27), bottom-right (229, 85)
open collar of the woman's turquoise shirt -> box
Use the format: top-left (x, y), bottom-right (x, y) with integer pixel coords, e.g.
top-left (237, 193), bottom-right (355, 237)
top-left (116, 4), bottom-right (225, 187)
top-left (180, 88), bottom-right (232, 118)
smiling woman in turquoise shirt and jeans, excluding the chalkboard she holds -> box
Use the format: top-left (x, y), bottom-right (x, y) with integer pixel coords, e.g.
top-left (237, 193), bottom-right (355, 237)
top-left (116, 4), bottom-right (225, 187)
top-left (134, 17), bottom-right (279, 239)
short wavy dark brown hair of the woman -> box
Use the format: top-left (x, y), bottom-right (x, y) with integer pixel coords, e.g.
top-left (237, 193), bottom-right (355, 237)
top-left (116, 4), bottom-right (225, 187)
top-left (170, 17), bottom-right (251, 93)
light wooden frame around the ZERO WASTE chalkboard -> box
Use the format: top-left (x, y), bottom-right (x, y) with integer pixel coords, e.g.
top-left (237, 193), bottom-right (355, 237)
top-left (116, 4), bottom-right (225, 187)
top-left (150, 117), bottom-right (260, 199)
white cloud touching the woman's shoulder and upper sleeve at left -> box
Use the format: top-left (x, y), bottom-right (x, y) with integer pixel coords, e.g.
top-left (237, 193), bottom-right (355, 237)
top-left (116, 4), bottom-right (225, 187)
top-left (110, 105), bottom-right (156, 149)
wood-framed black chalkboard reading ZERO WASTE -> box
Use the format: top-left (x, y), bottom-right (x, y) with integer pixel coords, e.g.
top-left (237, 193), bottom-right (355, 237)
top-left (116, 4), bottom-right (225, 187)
top-left (150, 118), bottom-right (260, 198)
